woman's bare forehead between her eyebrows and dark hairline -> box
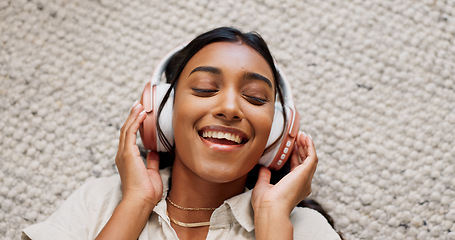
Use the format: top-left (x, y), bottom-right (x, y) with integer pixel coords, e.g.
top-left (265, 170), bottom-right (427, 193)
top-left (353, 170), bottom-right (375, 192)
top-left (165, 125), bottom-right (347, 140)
top-left (182, 42), bottom-right (275, 84)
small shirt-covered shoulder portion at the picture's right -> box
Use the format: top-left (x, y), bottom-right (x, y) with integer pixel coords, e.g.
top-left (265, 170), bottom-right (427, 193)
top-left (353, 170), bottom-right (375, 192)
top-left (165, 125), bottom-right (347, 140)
top-left (290, 207), bottom-right (340, 239)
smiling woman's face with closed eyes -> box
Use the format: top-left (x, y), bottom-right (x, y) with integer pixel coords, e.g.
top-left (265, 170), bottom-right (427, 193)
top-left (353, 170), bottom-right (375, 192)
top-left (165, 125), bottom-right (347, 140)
top-left (173, 42), bottom-right (275, 183)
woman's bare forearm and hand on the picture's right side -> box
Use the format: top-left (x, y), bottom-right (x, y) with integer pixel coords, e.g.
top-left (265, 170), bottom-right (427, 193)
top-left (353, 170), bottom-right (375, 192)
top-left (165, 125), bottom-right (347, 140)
top-left (251, 133), bottom-right (318, 240)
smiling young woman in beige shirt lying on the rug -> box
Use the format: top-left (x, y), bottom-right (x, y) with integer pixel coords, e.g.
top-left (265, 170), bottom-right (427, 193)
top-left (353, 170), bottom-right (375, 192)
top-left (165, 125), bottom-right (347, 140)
top-left (23, 28), bottom-right (339, 239)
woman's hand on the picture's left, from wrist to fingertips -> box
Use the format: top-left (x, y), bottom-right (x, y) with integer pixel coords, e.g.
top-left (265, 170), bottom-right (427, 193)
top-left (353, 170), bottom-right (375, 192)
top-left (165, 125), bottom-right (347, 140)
top-left (115, 102), bottom-right (163, 212)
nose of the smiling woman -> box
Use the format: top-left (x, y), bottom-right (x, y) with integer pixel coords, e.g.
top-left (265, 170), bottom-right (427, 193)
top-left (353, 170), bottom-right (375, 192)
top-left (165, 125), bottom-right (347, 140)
top-left (213, 88), bottom-right (244, 121)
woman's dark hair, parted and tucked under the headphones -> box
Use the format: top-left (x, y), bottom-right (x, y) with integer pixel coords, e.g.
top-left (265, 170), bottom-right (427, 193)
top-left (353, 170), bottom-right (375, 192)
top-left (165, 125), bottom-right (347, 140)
top-left (148, 27), bottom-right (343, 238)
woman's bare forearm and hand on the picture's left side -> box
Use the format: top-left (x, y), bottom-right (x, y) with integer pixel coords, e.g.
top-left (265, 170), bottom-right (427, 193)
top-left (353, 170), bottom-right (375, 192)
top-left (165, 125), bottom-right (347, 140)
top-left (96, 102), bottom-right (163, 239)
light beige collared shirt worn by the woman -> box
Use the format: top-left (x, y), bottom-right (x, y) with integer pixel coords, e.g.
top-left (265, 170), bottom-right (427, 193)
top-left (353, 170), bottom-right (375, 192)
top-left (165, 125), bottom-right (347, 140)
top-left (22, 168), bottom-right (340, 240)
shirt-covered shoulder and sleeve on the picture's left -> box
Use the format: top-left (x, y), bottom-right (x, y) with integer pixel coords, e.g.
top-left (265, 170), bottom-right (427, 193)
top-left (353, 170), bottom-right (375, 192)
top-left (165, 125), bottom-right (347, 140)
top-left (22, 175), bottom-right (121, 239)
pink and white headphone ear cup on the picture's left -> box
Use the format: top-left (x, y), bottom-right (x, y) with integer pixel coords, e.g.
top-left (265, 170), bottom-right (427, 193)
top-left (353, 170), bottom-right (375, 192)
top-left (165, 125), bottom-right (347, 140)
top-left (139, 83), bottom-right (174, 152)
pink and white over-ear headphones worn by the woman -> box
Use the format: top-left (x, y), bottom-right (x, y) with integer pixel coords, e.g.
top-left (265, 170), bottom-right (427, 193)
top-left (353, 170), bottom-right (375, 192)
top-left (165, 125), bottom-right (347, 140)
top-left (139, 45), bottom-right (299, 170)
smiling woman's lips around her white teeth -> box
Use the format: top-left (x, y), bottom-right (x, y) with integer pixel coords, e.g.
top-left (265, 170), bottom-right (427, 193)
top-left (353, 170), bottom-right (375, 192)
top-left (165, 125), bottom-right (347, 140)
top-left (198, 126), bottom-right (249, 152)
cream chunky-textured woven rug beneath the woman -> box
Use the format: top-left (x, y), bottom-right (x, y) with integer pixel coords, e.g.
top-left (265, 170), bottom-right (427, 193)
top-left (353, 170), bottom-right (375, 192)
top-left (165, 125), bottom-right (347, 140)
top-left (0, 0), bottom-right (455, 239)
